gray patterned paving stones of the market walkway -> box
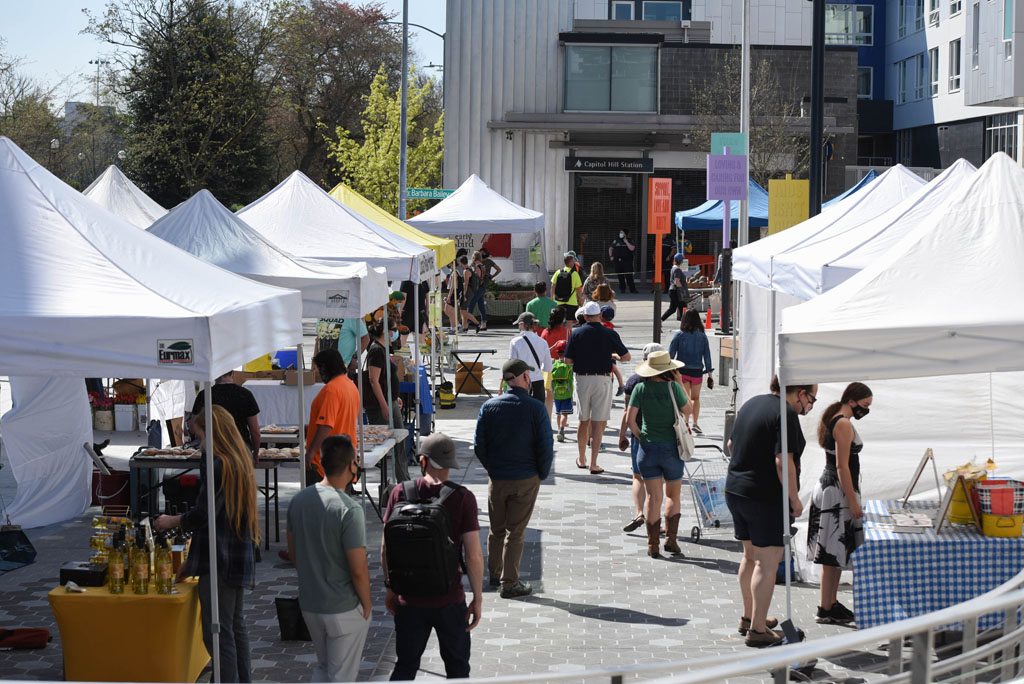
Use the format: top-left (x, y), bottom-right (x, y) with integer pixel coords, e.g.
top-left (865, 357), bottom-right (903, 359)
top-left (0, 295), bottom-right (881, 682)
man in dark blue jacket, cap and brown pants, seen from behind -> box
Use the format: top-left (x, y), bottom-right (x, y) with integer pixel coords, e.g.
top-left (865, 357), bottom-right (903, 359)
top-left (474, 358), bottom-right (554, 598)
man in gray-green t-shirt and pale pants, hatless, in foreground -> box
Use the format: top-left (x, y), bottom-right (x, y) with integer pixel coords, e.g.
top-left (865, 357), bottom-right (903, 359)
top-left (288, 434), bottom-right (371, 682)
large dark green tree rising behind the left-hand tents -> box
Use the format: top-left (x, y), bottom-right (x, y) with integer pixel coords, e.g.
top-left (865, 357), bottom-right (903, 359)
top-left (87, 0), bottom-right (274, 206)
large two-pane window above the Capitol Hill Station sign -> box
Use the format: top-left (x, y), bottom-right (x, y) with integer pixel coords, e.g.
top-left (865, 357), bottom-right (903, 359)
top-left (564, 45), bottom-right (657, 112)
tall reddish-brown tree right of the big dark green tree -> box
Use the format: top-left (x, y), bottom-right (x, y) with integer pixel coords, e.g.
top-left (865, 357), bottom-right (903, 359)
top-left (269, 0), bottom-right (401, 178)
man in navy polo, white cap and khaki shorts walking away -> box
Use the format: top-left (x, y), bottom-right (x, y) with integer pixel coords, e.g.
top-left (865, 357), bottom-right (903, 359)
top-left (565, 302), bottom-right (630, 475)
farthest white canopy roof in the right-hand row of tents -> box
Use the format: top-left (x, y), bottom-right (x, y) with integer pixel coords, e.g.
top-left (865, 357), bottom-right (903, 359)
top-left (732, 164), bottom-right (925, 290)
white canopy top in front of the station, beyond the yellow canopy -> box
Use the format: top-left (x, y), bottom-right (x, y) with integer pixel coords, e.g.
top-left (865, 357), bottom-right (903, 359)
top-left (407, 173), bottom-right (544, 236)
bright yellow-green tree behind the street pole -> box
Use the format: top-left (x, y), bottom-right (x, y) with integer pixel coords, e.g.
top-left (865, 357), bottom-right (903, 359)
top-left (327, 70), bottom-right (444, 214)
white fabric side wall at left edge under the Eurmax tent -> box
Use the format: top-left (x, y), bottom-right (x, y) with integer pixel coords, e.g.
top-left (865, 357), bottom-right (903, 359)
top-left (0, 376), bottom-right (92, 528)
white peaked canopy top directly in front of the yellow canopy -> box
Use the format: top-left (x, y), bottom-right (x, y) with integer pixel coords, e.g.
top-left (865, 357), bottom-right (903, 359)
top-left (238, 171), bottom-right (436, 283)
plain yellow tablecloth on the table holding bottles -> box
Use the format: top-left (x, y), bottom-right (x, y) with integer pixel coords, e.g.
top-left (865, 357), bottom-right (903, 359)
top-left (49, 582), bottom-right (210, 682)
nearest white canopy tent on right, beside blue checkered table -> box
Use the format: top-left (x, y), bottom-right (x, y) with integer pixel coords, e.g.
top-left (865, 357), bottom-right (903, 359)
top-left (778, 153), bottom-right (1024, 626)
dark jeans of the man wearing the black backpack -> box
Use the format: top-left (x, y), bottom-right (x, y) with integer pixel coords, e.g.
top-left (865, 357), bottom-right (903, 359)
top-left (391, 601), bottom-right (470, 681)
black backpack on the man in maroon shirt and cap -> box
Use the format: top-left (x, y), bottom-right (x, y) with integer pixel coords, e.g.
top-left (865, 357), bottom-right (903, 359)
top-left (384, 480), bottom-right (465, 597)
